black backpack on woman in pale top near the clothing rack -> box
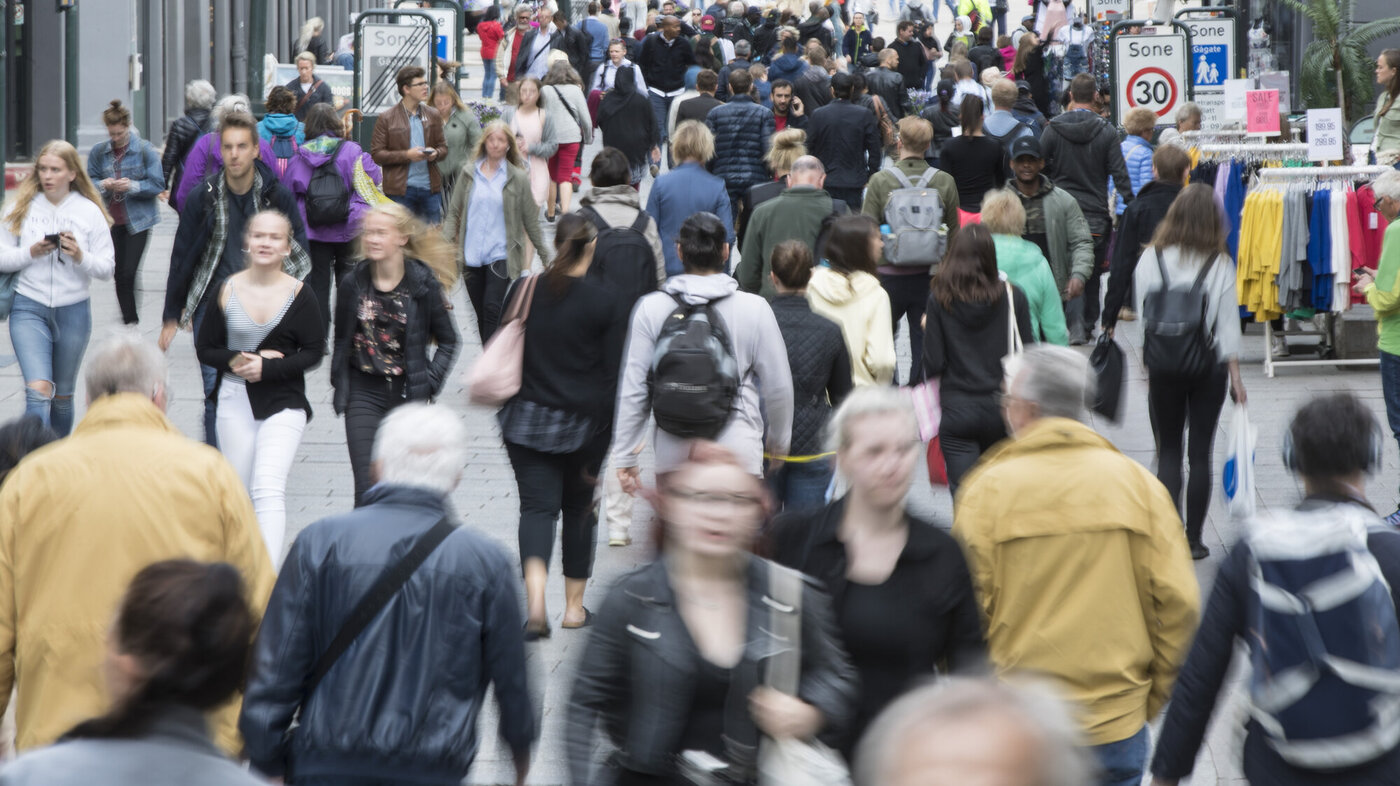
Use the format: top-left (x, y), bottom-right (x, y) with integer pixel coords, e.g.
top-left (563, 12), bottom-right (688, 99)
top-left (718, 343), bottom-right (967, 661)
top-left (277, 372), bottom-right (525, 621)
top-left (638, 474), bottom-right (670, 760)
top-left (1142, 248), bottom-right (1218, 378)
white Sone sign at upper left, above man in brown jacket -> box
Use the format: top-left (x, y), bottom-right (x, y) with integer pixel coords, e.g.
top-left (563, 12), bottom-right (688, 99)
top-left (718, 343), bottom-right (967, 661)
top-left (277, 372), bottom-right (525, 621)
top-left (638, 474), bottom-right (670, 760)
top-left (354, 10), bottom-right (437, 150)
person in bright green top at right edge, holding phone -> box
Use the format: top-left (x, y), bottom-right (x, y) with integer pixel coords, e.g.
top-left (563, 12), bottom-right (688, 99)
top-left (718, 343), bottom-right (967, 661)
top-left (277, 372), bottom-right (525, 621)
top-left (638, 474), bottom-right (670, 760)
top-left (1352, 171), bottom-right (1400, 527)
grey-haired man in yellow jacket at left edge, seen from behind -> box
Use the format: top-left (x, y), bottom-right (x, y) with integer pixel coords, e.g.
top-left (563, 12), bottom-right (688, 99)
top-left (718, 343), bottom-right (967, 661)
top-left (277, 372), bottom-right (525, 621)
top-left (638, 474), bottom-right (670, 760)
top-left (0, 336), bottom-right (276, 754)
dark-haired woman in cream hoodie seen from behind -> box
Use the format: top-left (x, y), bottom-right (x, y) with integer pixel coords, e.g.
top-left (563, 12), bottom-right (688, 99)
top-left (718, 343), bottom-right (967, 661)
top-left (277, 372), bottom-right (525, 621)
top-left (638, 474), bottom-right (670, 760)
top-left (806, 216), bottom-right (896, 385)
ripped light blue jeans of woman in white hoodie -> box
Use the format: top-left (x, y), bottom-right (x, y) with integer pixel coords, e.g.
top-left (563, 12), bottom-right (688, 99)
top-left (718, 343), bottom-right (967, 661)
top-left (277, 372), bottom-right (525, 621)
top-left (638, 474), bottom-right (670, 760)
top-left (10, 294), bottom-right (92, 437)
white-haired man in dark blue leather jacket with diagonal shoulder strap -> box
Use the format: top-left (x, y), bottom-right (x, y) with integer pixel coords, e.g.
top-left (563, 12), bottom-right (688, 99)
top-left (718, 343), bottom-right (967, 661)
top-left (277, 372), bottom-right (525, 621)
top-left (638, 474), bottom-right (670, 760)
top-left (239, 404), bottom-right (536, 786)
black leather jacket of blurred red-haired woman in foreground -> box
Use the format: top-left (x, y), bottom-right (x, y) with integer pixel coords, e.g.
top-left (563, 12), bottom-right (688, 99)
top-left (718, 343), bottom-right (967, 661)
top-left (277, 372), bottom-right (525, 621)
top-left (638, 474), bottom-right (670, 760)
top-left (564, 558), bottom-right (857, 786)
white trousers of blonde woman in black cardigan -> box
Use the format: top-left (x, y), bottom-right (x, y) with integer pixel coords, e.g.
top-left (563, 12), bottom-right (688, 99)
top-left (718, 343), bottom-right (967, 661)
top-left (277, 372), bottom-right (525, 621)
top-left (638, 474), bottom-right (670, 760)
top-left (214, 380), bottom-right (307, 567)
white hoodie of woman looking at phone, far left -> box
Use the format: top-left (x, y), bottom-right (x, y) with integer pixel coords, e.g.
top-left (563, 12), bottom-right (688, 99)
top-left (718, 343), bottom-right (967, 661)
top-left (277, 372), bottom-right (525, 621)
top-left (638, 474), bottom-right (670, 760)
top-left (0, 192), bottom-right (115, 308)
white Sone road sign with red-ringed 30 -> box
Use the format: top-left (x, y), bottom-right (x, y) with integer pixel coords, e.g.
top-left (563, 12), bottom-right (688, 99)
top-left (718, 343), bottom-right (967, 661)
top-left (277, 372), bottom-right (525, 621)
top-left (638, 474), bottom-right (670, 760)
top-left (1109, 20), bottom-right (1196, 126)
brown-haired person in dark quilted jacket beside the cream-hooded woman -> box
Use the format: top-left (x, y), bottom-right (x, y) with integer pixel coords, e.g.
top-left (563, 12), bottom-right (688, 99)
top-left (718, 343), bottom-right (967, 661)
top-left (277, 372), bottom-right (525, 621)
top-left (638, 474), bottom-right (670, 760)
top-left (764, 239), bottom-right (851, 510)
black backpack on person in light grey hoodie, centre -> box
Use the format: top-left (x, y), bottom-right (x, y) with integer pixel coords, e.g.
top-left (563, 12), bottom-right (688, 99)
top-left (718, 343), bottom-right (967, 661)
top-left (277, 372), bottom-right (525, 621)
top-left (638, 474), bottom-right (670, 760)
top-left (647, 293), bottom-right (739, 440)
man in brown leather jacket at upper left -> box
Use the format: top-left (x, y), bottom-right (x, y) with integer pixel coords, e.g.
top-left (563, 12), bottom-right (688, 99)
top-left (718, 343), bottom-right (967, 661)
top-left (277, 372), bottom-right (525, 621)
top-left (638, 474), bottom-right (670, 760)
top-left (370, 66), bottom-right (447, 224)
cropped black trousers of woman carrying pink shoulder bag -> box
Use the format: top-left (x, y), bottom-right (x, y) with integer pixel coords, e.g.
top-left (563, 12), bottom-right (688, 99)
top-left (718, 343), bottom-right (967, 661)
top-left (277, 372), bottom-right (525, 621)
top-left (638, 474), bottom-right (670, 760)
top-left (505, 433), bottom-right (612, 579)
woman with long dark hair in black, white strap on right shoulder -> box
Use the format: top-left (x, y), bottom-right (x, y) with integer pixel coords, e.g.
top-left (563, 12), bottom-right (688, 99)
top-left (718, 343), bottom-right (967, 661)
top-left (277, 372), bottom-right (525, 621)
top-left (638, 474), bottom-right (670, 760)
top-left (924, 224), bottom-right (1036, 490)
